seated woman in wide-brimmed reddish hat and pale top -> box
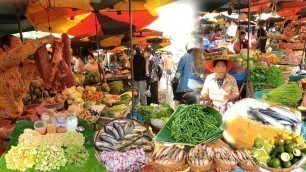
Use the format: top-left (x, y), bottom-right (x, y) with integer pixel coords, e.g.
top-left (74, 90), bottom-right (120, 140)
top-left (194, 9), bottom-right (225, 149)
top-left (201, 58), bottom-right (239, 114)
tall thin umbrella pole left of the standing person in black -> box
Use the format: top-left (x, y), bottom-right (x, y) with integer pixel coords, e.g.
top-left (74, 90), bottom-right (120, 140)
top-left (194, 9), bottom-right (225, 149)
top-left (129, 0), bottom-right (135, 116)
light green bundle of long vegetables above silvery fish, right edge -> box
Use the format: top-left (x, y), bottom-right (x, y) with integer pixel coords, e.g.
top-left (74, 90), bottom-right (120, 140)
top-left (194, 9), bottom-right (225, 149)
top-left (263, 83), bottom-right (303, 107)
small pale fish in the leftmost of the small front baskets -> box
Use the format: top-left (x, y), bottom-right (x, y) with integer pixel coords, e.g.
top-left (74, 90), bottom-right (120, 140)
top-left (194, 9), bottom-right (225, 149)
top-left (155, 146), bottom-right (184, 165)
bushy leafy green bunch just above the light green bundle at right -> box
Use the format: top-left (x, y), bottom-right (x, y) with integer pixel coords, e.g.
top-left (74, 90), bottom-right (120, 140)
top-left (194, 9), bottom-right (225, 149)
top-left (266, 66), bottom-right (285, 88)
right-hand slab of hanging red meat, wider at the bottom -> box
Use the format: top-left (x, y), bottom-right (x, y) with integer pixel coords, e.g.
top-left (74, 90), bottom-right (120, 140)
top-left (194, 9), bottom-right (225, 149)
top-left (50, 42), bottom-right (75, 91)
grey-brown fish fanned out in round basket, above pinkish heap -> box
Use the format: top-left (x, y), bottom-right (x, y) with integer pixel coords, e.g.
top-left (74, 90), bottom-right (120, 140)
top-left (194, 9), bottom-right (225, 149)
top-left (95, 120), bottom-right (154, 152)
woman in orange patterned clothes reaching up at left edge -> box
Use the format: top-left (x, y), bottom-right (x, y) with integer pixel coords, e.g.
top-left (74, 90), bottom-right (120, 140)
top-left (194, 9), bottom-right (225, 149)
top-left (0, 35), bottom-right (54, 148)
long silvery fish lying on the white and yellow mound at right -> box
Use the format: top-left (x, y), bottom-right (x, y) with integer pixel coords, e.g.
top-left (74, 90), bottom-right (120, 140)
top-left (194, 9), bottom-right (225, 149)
top-left (248, 106), bottom-right (301, 131)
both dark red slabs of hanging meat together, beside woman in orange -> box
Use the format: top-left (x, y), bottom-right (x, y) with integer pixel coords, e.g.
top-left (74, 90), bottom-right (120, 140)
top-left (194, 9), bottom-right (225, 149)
top-left (35, 34), bottom-right (76, 91)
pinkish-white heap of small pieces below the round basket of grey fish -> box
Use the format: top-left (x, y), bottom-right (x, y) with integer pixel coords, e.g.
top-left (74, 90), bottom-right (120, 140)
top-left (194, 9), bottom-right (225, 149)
top-left (99, 149), bottom-right (149, 172)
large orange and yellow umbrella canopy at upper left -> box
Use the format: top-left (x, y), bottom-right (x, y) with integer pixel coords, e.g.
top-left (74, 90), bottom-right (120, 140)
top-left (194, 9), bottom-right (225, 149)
top-left (26, 0), bottom-right (173, 37)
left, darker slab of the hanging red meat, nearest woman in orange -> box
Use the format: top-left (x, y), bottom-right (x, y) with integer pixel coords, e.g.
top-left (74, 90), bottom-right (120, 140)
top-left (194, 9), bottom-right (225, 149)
top-left (34, 46), bottom-right (51, 87)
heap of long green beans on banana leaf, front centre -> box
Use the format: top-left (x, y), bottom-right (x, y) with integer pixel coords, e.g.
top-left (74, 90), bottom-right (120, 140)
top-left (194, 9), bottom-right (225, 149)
top-left (171, 105), bottom-right (218, 144)
